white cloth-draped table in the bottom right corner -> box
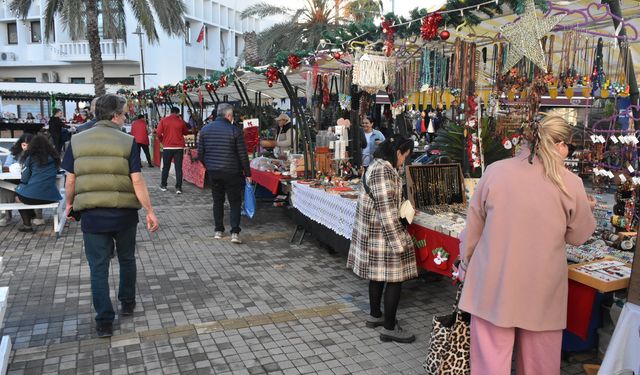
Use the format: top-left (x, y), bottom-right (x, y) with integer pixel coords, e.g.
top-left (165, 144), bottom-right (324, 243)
top-left (598, 302), bottom-right (640, 375)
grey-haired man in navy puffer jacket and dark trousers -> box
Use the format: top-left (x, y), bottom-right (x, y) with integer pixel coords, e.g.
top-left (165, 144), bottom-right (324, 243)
top-left (198, 103), bottom-right (251, 243)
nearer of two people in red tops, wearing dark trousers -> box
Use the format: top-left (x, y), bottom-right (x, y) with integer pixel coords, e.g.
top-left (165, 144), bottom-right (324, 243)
top-left (156, 107), bottom-right (189, 194)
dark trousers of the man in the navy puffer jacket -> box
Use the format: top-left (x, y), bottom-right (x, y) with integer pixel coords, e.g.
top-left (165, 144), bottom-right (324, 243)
top-left (209, 171), bottom-right (244, 233)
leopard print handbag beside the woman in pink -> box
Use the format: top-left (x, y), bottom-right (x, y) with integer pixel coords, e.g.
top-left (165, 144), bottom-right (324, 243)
top-left (423, 284), bottom-right (471, 375)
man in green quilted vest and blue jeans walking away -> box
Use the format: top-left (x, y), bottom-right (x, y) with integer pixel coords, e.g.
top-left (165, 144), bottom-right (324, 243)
top-left (62, 94), bottom-right (158, 337)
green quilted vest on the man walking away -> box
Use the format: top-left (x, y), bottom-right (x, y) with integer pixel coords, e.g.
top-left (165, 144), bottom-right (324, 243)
top-left (71, 120), bottom-right (141, 211)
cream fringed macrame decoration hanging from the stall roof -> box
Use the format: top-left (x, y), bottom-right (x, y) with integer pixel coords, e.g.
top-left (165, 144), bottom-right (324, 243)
top-left (353, 52), bottom-right (396, 94)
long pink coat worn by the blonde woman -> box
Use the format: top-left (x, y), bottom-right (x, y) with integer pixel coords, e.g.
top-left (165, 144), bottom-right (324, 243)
top-left (460, 152), bottom-right (596, 331)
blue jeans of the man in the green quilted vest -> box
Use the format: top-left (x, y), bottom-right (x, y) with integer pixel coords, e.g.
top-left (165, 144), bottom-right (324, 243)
top-left (83, 226), bottom-right (137, 322)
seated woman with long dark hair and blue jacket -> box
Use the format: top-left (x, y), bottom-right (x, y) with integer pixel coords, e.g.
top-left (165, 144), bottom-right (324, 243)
top-left (16, 135), bottom-right (62, 232)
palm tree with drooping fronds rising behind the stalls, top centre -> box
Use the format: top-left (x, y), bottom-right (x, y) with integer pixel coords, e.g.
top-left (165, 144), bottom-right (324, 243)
top-left (241, 0), bottom-right (382, 63)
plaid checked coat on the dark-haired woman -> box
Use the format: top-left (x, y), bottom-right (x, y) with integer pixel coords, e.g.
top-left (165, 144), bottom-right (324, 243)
top-left (347, 159), bottom-right (418, 282)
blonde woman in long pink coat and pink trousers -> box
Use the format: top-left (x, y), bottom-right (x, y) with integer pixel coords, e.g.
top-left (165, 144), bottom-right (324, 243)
top-left (459, 116), bottom-right (596, 375)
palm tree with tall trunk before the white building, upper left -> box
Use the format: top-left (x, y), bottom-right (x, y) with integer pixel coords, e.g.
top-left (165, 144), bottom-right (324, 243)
top-left (10, 0), bottom-right (186, 95)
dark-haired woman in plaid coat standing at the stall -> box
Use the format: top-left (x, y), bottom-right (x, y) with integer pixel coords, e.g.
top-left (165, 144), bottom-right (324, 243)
top-left (347, 135), bottom-right (418, 343)
